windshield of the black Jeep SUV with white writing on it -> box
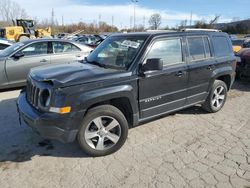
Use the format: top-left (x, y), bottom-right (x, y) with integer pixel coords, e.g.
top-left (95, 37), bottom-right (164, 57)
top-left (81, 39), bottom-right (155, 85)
top-left (86, 36), bottom-right (146, 70)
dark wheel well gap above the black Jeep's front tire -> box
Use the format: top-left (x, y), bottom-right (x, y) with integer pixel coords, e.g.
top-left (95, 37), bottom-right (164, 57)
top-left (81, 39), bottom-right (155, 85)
top-left (87, 97), bottom-right (133, 127)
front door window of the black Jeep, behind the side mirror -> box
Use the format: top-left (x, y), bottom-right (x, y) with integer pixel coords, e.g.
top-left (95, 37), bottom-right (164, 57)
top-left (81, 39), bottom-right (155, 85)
top-left (147, 39), bottom-right (183, 66)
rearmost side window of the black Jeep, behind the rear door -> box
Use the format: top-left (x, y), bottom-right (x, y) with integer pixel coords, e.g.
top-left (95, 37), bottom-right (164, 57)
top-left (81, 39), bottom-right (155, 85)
top-left (213, 36), bottom-right (232, 57)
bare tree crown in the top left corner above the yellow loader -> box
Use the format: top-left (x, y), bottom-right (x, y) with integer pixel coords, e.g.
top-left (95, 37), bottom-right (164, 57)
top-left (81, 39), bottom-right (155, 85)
top-left (0, 0), bottom-right (28, 23)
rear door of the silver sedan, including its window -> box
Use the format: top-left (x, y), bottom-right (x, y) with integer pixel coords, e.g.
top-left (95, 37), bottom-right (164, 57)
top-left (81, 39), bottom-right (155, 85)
top-left (51, 41), bottom-right (81, 64)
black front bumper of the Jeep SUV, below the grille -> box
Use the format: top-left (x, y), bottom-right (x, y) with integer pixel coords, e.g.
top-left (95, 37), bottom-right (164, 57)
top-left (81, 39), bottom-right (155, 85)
top-left (17, 92), bottom-right (83, 143)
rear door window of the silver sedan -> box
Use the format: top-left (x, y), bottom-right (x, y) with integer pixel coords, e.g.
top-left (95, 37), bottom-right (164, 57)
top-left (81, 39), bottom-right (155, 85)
top-left (53, 42), bottom-right (81, 54)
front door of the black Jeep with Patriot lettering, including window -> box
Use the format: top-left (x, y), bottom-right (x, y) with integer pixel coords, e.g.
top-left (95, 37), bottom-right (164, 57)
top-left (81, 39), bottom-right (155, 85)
top-left (139, 38), bottom-right (188, 119)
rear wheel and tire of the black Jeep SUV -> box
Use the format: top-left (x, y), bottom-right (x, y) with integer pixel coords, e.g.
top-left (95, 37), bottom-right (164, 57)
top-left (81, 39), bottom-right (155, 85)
top-left (202, 80), bottom-right (228, 113)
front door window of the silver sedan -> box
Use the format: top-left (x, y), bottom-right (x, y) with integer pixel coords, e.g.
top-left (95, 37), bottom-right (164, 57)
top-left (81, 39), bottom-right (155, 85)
top-left (22, 42), bottom-right (48, 56)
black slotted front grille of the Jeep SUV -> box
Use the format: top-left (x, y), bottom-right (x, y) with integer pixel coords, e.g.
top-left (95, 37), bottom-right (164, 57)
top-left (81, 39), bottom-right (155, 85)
top-left (27, 81), bottom-right (40, 108)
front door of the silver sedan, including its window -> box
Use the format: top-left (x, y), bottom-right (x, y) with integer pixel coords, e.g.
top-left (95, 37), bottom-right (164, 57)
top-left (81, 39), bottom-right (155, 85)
top-left (6, 42), bottom-right (50, 85)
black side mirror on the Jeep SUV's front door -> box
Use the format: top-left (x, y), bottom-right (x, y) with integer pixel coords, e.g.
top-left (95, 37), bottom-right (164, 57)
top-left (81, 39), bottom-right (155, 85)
top-left (142, 58), bottom-right (163, 73)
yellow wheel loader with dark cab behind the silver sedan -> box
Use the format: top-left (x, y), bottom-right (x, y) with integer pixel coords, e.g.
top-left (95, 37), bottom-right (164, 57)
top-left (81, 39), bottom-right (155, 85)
top-left (0, 19), bottom-right (51, 42)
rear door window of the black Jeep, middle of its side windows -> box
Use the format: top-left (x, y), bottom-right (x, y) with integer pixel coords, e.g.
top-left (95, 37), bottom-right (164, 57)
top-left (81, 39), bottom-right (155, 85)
top-left (187, 37), bottom-right (211, 61)
